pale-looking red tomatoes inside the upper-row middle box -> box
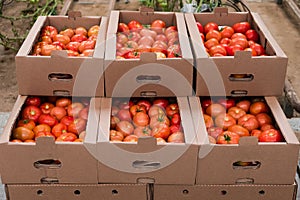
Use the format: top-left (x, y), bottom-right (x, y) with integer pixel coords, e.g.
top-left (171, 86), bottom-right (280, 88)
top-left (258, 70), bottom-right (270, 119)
top-left (116, 19), bottom-right (181, 59)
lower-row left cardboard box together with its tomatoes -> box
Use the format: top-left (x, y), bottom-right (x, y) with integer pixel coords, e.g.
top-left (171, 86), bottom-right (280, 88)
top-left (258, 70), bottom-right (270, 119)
top-left (0, 95), bottom-right (101, 184)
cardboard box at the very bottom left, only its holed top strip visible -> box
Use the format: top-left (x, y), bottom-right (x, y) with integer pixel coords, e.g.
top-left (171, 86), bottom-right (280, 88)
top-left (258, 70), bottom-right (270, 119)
top-left (6, 184), bottom-right (150, 200)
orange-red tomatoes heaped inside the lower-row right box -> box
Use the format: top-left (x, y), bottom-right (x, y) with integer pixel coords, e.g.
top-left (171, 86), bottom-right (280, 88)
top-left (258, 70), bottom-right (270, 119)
top-left (201, 98), bottom-right (284, 144)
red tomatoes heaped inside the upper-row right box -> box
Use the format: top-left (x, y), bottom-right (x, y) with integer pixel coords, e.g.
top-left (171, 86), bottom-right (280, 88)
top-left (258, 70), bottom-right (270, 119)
top-left (196, 21), bottom-right (266, 56)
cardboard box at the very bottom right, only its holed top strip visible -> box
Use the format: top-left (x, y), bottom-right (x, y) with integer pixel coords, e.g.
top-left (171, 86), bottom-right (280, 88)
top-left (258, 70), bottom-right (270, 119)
top-left (153, 183), bottom-right (297, 200)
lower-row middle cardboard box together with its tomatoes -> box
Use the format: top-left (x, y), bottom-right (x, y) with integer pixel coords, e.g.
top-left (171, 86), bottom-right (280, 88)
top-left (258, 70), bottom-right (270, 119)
top-left (97, 97), bottom-right (199, 185)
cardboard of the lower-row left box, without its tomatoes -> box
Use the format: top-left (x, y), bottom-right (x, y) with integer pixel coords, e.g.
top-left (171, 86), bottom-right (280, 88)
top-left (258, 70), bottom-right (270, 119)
top-left (0, 96), bottom-right (101, 184)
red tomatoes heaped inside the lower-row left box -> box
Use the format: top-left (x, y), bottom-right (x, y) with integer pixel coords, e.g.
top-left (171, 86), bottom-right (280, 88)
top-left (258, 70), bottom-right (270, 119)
top-left (11, 96), bottom-right (90, 142)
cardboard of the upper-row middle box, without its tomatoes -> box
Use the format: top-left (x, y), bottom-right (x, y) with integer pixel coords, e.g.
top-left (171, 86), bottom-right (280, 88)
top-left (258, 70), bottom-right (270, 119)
top-left (104, 11), bottom-right (193, 97)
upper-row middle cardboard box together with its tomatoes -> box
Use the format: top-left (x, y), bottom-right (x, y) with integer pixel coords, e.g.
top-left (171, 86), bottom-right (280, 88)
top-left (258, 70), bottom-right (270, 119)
top-left (104, 9), bottom-right (193, 97)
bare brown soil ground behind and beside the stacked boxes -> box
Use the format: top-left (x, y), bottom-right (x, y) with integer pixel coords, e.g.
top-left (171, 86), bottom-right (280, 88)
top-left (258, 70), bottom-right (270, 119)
top-left (0, 0), bottom-right (300, 112)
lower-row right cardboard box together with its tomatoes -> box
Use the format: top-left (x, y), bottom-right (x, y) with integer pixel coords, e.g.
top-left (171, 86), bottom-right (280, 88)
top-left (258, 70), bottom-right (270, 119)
top-left (189, 97), bottom-right (299, 184)
